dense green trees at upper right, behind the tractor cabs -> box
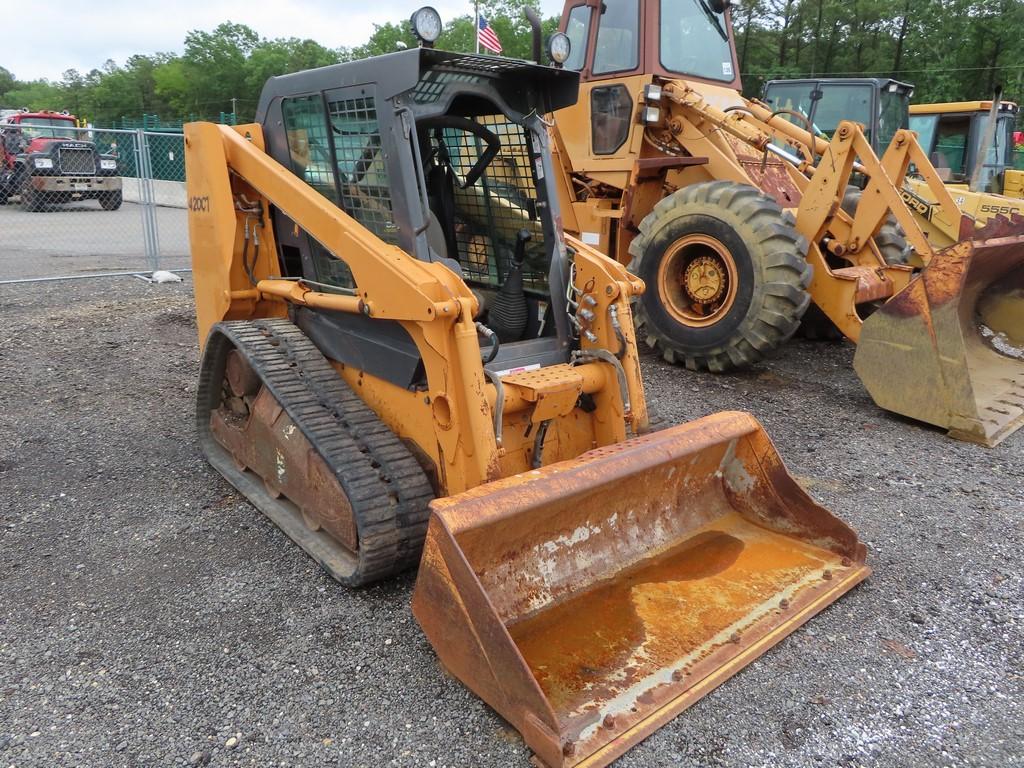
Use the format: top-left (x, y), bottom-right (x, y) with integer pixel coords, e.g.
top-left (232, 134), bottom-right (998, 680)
top-left (732, 0), bottom-right (1024, 102)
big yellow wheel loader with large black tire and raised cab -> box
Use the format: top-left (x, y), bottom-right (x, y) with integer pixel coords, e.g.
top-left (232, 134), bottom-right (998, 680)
top-left (552, 0), bottom-right (1024, 445)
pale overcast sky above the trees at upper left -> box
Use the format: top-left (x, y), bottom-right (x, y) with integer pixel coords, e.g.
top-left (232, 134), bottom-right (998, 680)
top-left (0, 0), bottom-right (562, 80)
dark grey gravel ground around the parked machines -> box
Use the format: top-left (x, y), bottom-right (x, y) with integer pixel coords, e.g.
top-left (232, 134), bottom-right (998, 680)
top-left (0, 279), bottom-right (1024, 768)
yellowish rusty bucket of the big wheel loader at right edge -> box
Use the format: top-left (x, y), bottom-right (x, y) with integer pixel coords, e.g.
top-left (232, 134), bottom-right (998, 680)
top-left (853, 236), bottom-right (1024, 446)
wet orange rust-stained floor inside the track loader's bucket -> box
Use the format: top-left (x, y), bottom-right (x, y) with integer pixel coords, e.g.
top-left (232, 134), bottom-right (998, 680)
top-left (509, 514), bottom-right (825, 714)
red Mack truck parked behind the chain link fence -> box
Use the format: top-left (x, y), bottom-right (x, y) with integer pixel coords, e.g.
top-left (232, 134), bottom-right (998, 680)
top-left (0, 110), bottom-right (122, 211)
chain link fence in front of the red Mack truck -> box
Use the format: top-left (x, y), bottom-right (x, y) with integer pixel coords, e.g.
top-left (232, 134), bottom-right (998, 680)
top-left (0, 120), bottom-right (189, 283)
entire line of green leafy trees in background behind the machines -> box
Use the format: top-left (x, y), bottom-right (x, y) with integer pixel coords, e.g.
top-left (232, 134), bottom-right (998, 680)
top-left (0, 0), bottom-right (1024, 125)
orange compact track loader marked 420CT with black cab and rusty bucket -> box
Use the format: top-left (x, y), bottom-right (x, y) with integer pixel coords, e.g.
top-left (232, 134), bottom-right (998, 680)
top-left (185, 9), bottom-right (869, 768)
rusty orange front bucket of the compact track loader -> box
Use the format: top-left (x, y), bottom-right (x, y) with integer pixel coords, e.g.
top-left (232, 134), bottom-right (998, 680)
top-left (413, 413), bottom-right (869, 768)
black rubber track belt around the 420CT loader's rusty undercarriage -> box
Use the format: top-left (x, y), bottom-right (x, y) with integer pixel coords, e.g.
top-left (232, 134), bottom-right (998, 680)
top-left (196, 319), bottom-right (434, 586)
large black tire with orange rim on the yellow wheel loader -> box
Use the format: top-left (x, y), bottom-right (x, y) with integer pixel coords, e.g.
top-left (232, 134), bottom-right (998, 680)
top-left (630, 181), bottom-right (812, 373)
